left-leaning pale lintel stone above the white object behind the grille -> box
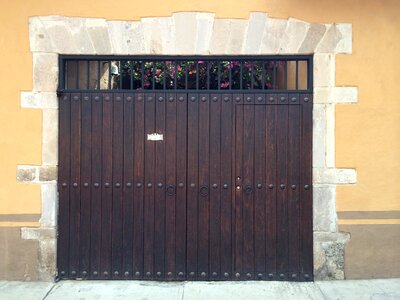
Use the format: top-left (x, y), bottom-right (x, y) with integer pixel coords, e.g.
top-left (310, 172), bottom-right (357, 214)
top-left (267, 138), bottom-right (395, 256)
top-left (85, 19), bottom-right (113, 54)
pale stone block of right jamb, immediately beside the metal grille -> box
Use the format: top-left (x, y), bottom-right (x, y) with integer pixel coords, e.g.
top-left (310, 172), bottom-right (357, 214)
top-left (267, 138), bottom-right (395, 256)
top-left (314, 54), bottom-right (335, 87)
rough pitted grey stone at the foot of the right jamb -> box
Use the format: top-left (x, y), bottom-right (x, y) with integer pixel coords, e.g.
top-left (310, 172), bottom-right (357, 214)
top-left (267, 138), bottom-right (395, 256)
top-left (314, 232), bottom-right (350, 280)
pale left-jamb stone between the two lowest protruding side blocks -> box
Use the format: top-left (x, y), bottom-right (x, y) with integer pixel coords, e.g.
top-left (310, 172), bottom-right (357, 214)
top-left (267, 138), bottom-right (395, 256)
top-left (40, 183), bottom-right (58, 227)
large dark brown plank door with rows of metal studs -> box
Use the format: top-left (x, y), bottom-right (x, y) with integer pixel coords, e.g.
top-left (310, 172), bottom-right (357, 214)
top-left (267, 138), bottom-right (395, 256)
top-left (58, 93), bottom-right (312, 280)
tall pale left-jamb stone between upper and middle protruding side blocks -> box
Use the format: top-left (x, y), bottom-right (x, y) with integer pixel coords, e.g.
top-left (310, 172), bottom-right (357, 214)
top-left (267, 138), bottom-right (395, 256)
top-left (42, 109), bottom-right (58, 166)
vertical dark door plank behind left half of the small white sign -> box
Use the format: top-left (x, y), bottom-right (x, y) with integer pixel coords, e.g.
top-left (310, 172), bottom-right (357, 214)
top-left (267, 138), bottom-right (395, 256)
top-left (144, 93), bottom-right (155, 279)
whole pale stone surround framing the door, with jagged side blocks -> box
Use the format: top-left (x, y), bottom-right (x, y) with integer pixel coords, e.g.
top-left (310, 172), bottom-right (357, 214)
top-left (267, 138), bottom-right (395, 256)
top-left (17, 12), bottom-right (358, 281)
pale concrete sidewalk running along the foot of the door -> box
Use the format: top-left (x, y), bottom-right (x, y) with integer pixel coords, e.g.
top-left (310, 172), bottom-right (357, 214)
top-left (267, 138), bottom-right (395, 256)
top-left (0, 278), bottom-right (400, 300)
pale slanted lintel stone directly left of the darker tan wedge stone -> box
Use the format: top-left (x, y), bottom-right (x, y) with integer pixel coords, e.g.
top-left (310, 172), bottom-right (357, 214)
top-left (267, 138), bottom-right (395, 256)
top-left (278, 18), bottom-right (310, 54)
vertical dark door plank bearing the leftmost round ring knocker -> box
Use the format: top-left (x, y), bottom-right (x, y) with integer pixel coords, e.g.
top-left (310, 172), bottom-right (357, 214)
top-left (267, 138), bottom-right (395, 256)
top-left (165, 94), bottom-right (177, 279)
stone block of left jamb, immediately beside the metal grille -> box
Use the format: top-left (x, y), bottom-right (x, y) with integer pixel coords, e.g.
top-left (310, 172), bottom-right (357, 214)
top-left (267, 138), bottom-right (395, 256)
top-left (33, 53), bottom-right (58, 92)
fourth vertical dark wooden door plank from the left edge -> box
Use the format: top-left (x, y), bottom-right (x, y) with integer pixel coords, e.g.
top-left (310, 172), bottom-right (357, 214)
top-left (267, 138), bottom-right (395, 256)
top-left (90, 93), bottom-right (103, 279)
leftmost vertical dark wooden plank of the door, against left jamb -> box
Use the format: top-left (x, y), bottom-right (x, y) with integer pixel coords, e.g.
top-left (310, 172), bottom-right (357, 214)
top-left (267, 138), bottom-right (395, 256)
top-left (57, 93), bottom-right (72, 278)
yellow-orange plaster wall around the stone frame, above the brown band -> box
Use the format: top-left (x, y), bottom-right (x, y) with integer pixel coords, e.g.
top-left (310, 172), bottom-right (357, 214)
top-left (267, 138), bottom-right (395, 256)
top-left (0, 0), bottom-right (400, 214)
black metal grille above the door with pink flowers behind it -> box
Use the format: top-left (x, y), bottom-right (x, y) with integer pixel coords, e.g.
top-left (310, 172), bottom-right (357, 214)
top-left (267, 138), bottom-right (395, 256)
top-left (59, 56), bottom-right (312, 93)
